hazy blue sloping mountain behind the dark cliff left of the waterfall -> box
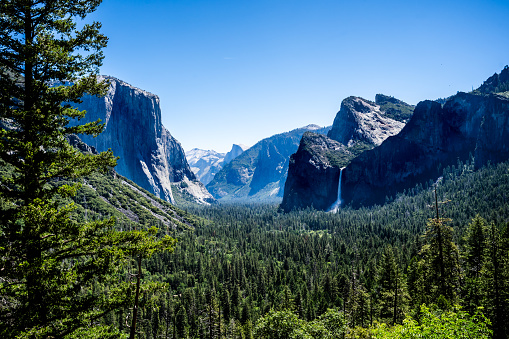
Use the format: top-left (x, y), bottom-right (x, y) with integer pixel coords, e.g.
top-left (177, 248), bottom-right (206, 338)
top-left (207, 125), bottom-right (330, 201)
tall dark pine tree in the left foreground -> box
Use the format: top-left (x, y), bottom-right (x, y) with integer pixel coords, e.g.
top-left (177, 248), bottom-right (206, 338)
top-left (0, 0), bottom-right (173, 338)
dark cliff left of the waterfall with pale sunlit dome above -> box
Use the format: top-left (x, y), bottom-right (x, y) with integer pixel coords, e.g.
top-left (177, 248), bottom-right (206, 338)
top-left (281, 94), bottom-right (413, 211)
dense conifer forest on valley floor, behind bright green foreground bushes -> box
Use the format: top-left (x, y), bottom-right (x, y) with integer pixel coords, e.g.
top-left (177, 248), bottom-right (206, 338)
top-left (102, 163), bottom-right (509, 338)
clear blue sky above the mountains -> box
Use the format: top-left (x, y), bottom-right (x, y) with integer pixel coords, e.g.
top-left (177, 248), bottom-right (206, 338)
top-left (91, 0), bottom-right (509, 152)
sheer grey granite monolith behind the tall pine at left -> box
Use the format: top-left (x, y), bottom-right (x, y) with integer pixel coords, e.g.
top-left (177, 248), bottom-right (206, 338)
top-left (73, 77), bottom-right (213, 203)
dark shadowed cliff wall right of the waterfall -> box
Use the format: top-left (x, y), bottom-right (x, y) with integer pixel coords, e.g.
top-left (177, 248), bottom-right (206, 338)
top-left (342, 93), bottom-right (509, 206)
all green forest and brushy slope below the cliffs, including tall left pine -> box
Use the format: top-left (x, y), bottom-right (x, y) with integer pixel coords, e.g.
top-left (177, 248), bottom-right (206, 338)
top-left (0, 0), bottom-right (509, 339)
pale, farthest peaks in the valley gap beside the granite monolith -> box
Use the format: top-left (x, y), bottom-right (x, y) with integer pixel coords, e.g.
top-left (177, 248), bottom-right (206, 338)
top-left (186, 144), bottom-right (247, 185)
